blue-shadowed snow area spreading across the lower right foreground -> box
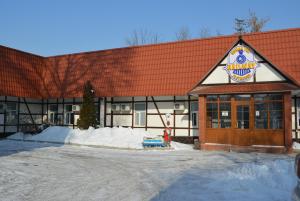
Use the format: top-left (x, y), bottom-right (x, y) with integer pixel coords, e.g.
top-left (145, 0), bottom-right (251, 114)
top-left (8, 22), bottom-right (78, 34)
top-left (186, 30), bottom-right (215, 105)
top-left (159, 159), bottom-right (297, 201)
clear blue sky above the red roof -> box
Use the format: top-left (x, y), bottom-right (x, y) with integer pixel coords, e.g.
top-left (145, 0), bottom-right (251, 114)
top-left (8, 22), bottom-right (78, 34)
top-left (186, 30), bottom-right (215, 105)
top-left (0, 0), bottom-right (300, 56)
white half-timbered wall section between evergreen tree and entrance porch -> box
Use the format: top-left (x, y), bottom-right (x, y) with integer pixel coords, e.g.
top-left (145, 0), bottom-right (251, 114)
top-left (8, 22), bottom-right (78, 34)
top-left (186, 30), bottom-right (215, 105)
top-left (104, 96), bottom-right (199, 137)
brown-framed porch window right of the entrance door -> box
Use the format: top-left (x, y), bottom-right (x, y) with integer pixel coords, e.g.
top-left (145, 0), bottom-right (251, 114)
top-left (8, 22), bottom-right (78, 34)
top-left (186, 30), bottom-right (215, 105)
top-left (254, 94), bottom-right (283, 129)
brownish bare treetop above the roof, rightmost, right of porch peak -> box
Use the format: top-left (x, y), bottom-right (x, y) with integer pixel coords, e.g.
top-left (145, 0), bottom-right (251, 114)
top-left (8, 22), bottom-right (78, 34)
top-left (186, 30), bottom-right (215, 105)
top-left (246, 10), bottom-right (270, 33)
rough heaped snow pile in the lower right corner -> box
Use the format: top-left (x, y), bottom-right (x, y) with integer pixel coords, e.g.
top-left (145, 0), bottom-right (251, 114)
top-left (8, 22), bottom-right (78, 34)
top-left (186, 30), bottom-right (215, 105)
top-left (206, 160), bottom-right (296, 200)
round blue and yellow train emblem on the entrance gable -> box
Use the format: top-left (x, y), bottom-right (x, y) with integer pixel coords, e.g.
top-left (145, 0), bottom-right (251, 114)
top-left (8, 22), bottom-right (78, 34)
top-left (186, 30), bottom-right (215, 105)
top-left (224, 45), bottom-right (258, 82)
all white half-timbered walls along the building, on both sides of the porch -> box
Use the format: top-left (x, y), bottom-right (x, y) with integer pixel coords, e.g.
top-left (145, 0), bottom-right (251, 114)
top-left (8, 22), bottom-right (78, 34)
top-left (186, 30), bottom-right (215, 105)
top-left (0, 95), bottom-right (300, 141)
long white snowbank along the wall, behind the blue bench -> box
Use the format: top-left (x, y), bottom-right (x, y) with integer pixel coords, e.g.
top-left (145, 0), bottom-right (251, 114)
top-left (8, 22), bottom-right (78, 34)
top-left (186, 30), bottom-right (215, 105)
top-left (8, 126), bottom-right (192, 150)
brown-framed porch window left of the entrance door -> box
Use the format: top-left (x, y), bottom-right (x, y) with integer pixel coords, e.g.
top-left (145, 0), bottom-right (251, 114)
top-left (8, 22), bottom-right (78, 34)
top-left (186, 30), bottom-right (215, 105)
top-left (206, 95), bottom-right (231, 128)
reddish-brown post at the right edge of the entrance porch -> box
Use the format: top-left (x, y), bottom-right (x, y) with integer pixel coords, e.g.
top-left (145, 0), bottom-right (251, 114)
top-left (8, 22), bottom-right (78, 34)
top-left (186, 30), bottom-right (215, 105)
top-left (283, 92), bottom-right (292, 152)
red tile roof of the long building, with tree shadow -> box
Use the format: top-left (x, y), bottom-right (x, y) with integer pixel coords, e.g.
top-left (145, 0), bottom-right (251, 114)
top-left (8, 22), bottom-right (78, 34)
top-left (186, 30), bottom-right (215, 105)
top-left (0, 28), bottom-right (300, 98)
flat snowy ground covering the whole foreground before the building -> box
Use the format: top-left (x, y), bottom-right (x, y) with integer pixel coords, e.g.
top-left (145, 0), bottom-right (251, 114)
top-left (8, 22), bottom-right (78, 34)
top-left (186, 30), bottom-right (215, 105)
top-left (0, 140), bottom-right (296, 201)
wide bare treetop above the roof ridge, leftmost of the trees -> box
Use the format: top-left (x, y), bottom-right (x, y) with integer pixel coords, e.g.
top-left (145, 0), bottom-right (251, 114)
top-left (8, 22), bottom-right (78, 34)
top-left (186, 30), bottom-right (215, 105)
top-left (125, 29), bottom-right (161, 46)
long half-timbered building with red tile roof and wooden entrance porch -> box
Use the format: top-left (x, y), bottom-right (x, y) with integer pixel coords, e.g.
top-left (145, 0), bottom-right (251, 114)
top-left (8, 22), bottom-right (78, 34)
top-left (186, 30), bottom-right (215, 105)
top-left (0, 28), bottom-right (300, 151)
